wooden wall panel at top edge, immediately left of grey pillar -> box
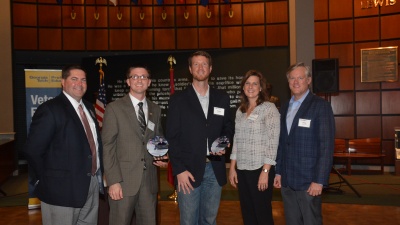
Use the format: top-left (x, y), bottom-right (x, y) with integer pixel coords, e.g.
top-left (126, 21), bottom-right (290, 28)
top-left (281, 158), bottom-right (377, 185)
top-left (265, 1), bottom-right (289, 23)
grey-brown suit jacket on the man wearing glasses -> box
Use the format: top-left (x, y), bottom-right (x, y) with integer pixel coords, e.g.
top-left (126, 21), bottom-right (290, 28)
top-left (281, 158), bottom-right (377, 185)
top-left (102, 94), bottom-right (163, 196)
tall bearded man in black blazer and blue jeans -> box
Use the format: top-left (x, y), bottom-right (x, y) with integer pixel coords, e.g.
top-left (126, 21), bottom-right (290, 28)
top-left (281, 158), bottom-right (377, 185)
top-left (167, 51), bottom-right (233, 225)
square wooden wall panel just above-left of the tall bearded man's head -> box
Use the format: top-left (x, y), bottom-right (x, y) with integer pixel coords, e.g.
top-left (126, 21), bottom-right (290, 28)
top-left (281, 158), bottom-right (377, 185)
top-left (176, 28), bottom-right (201, 49)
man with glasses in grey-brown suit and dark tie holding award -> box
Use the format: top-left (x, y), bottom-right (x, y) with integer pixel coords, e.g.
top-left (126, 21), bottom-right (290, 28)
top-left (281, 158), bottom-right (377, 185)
top-left (102, 66), bottom-right (167, 225)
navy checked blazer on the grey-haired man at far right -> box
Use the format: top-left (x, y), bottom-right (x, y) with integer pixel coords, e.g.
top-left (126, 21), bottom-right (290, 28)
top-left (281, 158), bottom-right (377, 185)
top-left (276, 92), bottom-right (335, 191)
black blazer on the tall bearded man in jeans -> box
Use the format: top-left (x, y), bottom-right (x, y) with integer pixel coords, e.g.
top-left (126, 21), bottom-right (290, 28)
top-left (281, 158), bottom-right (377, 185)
top-left (167, 85), bottom-right (233, 187)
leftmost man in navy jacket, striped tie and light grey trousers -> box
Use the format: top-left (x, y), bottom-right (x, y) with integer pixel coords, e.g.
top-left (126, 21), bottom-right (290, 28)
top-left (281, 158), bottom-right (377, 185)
top-left (24, 66), bottom-right (103, 225)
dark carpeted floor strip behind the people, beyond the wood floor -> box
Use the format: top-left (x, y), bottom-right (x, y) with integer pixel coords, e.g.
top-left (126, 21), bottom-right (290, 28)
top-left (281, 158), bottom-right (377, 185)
top-left (0, 169), bottom-right (400, 207)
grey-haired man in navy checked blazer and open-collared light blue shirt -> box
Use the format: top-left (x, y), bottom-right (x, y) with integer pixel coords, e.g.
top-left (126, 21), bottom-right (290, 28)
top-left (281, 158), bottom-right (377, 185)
top-left (274, 63), bottom-right (335, 225)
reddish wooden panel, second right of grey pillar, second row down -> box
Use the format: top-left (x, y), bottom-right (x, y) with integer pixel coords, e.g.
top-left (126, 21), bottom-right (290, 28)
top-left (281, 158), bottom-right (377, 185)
top-left (329, 20), bottom-right (353, 43)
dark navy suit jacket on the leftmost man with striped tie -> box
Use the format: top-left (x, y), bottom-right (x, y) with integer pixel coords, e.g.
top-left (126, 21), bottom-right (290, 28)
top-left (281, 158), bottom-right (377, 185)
top-left (24, 93), bottom-right (103, 208)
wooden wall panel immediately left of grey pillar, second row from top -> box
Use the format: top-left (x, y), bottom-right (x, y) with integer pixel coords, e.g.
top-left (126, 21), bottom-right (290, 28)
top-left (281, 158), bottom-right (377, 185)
top-left (266, 24), bottom-right (289, 47)
